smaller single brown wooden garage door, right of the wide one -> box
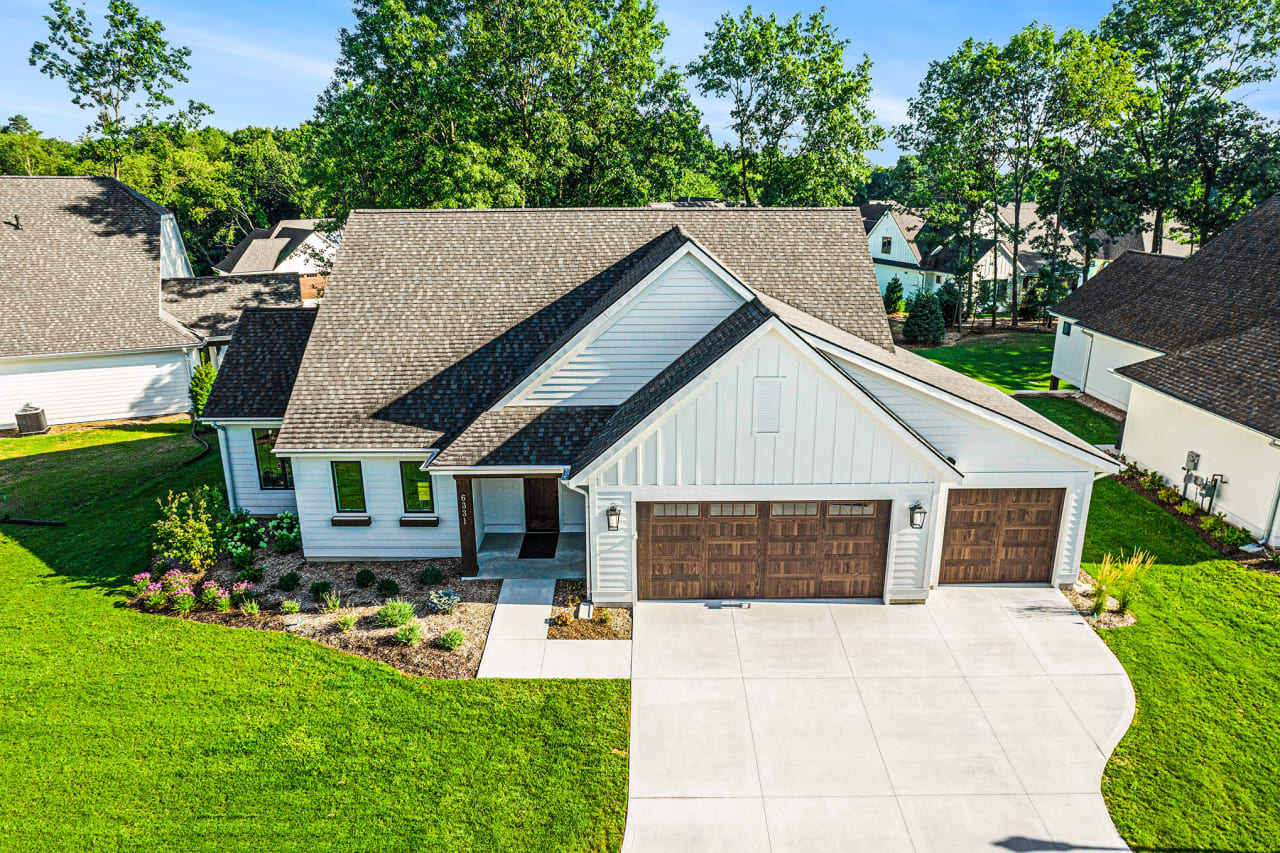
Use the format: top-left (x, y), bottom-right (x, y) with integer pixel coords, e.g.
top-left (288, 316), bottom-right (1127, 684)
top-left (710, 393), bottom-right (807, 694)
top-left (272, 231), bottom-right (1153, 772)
top-left (940, 489), bottom-right (1066, 584)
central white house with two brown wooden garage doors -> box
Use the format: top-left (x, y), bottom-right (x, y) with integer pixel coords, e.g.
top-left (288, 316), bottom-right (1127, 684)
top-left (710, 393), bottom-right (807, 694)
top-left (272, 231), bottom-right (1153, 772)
top-left (205, 209), bottom-right (1117, 601)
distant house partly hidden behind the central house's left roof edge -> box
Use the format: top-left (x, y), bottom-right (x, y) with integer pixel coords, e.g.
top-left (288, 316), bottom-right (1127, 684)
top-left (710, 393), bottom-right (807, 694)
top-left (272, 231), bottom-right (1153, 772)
top-left (214, 219), bottom-right (342, 301)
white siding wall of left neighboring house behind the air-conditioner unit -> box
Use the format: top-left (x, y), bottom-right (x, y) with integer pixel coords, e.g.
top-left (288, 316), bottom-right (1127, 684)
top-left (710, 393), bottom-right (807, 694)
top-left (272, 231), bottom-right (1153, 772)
top-left (0, 350), bottom-right (191, 429)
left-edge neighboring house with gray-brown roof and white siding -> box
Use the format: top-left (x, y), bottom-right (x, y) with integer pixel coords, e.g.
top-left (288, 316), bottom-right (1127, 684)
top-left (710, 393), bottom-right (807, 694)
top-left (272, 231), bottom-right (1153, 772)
top-left (0, 177), bottom-right (298, 429)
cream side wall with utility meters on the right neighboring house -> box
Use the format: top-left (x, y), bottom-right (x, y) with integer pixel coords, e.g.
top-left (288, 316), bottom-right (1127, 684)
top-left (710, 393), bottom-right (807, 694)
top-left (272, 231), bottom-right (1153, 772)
top-left (1123, 384), bottom-right (1280, 544)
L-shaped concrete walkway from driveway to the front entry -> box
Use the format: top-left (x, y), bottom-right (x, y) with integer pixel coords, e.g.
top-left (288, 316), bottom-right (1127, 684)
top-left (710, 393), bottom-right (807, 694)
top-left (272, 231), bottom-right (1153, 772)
top-left (477, 579), bottom-right (631, 679)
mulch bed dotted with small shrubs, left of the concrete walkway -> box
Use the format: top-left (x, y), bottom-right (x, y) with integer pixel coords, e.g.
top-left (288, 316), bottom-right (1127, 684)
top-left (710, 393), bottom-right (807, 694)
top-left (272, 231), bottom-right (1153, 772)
top-left (131, 547), bottom-right (502, 679)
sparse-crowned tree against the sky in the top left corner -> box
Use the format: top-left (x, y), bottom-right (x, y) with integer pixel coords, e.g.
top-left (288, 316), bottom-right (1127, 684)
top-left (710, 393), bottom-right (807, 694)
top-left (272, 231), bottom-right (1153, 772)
top-left (29, 0), bottom-right (209, 178)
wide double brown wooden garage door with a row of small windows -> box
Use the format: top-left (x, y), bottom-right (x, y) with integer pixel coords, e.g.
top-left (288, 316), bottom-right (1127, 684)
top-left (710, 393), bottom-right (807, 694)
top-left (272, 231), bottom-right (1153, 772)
top-left (636, 501), bottom-right (891, 599)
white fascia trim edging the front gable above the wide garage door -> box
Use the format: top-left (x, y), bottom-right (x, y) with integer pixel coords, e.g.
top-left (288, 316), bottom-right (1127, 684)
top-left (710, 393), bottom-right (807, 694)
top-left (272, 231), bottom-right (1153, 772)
top-left (570, 316), bottom-right (964, 487)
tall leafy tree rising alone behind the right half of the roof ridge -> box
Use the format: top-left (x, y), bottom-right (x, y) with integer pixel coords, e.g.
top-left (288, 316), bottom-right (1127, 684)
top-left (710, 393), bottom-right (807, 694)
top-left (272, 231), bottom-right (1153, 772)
top-left (689, 6), bottom-right (884, 205)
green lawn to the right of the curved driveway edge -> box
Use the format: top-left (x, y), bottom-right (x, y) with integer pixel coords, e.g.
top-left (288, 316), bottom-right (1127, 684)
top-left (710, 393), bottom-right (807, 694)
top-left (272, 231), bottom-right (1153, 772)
top-left (1083, 479), bottom-right (1280, 850)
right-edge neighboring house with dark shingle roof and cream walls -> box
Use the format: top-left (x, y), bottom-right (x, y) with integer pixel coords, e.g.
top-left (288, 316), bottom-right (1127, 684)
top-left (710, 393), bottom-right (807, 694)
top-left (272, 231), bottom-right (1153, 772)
top-left (1052, 196), bottom-right (1280, 544)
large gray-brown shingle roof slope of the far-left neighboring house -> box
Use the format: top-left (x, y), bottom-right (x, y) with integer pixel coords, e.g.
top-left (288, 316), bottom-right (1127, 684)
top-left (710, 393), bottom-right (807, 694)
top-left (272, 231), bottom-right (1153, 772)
top-left (0, 177), bottom-right (196, 357)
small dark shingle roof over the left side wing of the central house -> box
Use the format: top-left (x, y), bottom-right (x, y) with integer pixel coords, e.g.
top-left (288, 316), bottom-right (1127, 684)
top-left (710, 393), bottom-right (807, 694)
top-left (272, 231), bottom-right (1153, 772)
top-left (202, 307), bottom-right (316, 420)
